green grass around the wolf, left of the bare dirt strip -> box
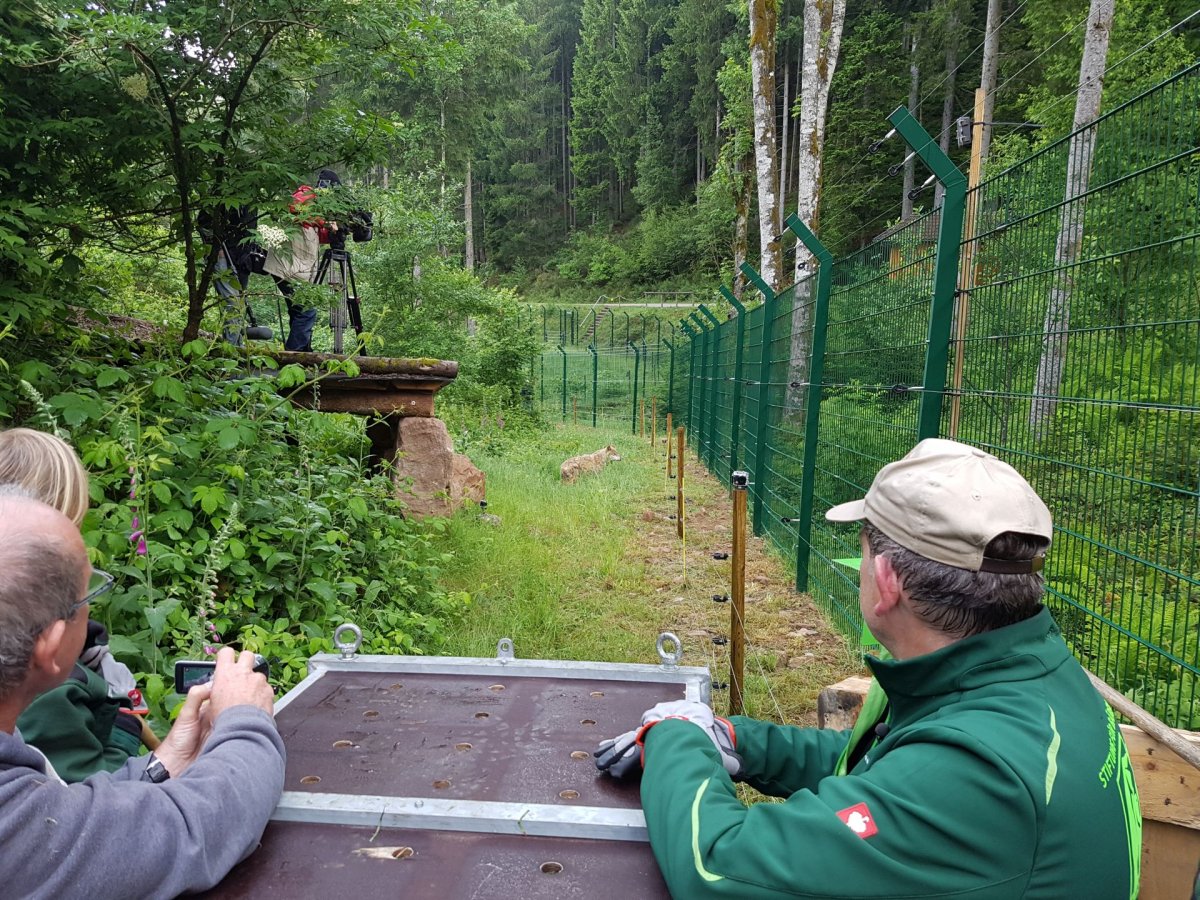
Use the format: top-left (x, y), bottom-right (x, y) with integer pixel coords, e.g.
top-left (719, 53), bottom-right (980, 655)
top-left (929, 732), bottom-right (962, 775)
top-left (443, 424), bottom-right (666, 662)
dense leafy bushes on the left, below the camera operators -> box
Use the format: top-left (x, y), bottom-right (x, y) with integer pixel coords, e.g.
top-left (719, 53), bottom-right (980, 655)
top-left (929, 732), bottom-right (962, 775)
top-left (0, 332), bottom-right (469, 713)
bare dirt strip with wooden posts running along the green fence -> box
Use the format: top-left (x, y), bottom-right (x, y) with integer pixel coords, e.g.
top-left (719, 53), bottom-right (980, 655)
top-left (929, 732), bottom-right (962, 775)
top-left (637, 441), bottom-right (863, 725)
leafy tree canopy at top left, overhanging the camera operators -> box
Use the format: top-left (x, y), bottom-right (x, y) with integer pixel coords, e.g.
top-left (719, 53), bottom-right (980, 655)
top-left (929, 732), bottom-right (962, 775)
top-left (0, 0), bottom-right (438, 338)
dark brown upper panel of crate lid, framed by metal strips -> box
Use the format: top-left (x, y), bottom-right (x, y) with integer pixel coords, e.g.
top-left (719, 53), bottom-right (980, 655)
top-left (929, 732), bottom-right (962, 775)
top-left (276, 661), bottom-right (685, 809)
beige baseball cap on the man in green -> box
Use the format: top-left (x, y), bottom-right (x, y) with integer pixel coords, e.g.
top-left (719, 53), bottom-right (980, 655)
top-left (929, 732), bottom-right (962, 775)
top-left (826, 438), bottom-right (1054, 575)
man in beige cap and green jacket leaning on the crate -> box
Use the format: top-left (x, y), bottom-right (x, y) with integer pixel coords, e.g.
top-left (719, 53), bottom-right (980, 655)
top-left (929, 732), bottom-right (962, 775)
top-left (598, 439), bottom-right (1141, 900)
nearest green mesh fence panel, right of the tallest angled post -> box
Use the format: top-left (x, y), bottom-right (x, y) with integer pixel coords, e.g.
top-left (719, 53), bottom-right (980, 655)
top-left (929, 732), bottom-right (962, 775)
top-left (943, 66), bottom-right (1200, 727)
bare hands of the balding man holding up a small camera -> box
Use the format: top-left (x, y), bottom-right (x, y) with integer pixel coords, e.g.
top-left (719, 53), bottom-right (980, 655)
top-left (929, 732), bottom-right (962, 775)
top-left (155, 647), bottom-right (275, 778)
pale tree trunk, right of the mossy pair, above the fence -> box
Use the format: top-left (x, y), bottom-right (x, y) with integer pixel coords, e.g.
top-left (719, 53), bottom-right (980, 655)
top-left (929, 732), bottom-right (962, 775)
top-left (796, 0), bottom-right (846, 281)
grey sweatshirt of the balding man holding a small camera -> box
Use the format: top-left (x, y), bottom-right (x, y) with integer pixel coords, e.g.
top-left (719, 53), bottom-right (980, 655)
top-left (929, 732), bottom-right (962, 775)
top-left (0, 706), bottom-right (283, 900)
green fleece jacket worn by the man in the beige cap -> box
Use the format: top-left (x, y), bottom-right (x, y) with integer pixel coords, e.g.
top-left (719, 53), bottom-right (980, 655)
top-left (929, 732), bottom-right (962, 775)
top-left (642, 608), bottom-right (1141, 900)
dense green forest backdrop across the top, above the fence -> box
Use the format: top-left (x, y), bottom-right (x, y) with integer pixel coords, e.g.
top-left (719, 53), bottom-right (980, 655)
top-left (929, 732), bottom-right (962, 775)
top-left (0, 0), bottom-right (1200, 319)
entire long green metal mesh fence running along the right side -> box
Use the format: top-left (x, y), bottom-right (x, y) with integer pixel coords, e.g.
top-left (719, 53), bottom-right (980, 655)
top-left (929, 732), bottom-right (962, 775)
top-left (540, 64), bottom-right (1200, 728)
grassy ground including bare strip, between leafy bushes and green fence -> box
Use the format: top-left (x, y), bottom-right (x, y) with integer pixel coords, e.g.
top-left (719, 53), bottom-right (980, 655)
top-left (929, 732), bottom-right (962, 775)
top-left (442, 421), bottom-right (862, 724)
